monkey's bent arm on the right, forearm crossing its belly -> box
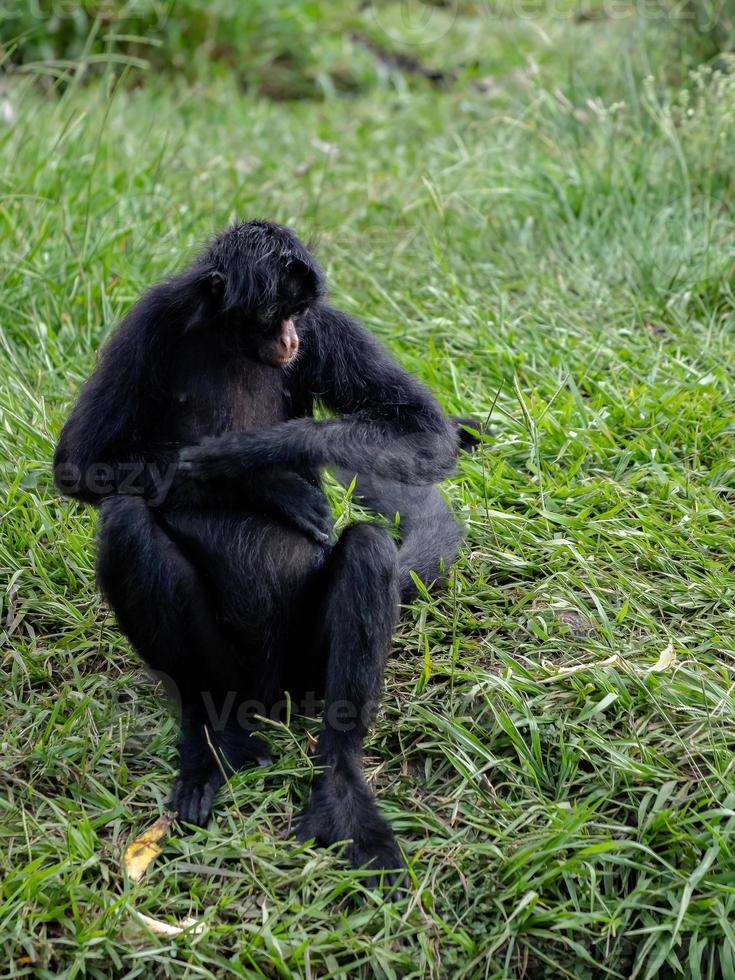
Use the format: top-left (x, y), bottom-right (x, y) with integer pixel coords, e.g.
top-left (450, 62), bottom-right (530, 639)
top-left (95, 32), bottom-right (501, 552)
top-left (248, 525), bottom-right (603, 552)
top-left (180, 304), bottom-right (459, 485)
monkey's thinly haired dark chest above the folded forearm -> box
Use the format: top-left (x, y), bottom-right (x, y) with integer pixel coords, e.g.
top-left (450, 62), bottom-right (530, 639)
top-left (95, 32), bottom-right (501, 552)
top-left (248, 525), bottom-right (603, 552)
top-left (167, 361), bottom-right (292, 443)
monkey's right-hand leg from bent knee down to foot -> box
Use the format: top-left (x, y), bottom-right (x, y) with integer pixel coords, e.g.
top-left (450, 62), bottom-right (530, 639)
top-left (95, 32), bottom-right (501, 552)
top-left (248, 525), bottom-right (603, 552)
top-left (297, 524), bottom-right (403, 883)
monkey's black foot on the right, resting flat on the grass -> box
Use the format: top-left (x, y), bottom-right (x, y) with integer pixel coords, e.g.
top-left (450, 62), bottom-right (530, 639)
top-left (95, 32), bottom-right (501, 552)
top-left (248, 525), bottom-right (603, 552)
top-left (296, 772), bottom-right (406, 889)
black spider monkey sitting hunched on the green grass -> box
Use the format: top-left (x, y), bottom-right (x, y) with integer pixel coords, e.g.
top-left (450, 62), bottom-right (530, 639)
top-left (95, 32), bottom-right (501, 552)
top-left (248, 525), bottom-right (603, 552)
top-left (54, 221), bottom-right (477, 880)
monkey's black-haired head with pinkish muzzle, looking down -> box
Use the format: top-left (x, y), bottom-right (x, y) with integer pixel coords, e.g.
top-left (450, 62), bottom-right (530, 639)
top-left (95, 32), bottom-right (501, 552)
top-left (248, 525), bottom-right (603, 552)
top-left (197, 221), bottom-right (324, 367)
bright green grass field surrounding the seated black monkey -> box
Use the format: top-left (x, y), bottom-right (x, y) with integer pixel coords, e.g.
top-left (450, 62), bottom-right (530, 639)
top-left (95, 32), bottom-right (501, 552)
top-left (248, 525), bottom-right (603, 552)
top-left (0, 3), bottom-right (735, 980)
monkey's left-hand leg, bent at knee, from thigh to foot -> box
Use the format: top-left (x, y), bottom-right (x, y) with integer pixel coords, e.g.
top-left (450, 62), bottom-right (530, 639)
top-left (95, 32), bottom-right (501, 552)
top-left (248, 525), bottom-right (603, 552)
top-left (97, 495), bottom-right (267, 826)
